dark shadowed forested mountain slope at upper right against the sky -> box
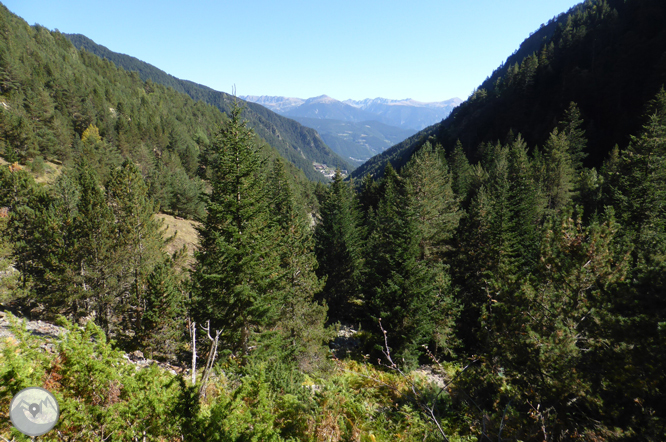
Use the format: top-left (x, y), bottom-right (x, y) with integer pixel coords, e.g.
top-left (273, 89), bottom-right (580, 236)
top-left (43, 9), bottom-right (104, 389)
top-left (353, 0), bottom-right (666, 177)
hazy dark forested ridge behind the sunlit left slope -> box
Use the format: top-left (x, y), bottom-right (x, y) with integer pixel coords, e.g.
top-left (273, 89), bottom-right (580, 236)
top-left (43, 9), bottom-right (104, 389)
top-left (65, 34), bottom-right (354, 181)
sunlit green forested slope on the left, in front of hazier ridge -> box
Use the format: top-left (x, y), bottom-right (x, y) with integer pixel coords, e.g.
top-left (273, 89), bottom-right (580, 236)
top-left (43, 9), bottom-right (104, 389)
top-left (0, 6), bottom-right (321, 218)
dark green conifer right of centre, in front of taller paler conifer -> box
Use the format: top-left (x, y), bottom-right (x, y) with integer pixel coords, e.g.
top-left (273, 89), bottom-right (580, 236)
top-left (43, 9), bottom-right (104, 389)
top-left (365, 164), bottom-right (457, 364)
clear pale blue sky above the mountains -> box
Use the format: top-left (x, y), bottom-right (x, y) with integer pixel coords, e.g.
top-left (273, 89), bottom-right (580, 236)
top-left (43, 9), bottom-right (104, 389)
top-left (1, 0), bottom-right (579, 101)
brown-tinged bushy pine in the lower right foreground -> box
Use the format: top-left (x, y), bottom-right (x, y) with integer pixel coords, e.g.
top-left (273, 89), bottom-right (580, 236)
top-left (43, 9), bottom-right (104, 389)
top-left (482, 208), bottom-right (626, 440)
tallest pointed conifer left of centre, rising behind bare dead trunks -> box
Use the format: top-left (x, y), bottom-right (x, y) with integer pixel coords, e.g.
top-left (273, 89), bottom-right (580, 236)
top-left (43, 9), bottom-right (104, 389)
top-left (192, 106), bottom-right (280, 357)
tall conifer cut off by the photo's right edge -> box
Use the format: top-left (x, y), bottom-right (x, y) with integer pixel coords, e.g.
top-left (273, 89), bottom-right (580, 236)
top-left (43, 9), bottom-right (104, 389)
top-left (600, 90), bottom-right (666, 426)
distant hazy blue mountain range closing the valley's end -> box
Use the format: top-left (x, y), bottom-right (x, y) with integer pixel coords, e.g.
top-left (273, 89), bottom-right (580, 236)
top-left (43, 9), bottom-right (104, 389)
top-left (241, 95), bottom-right (462, 165)
